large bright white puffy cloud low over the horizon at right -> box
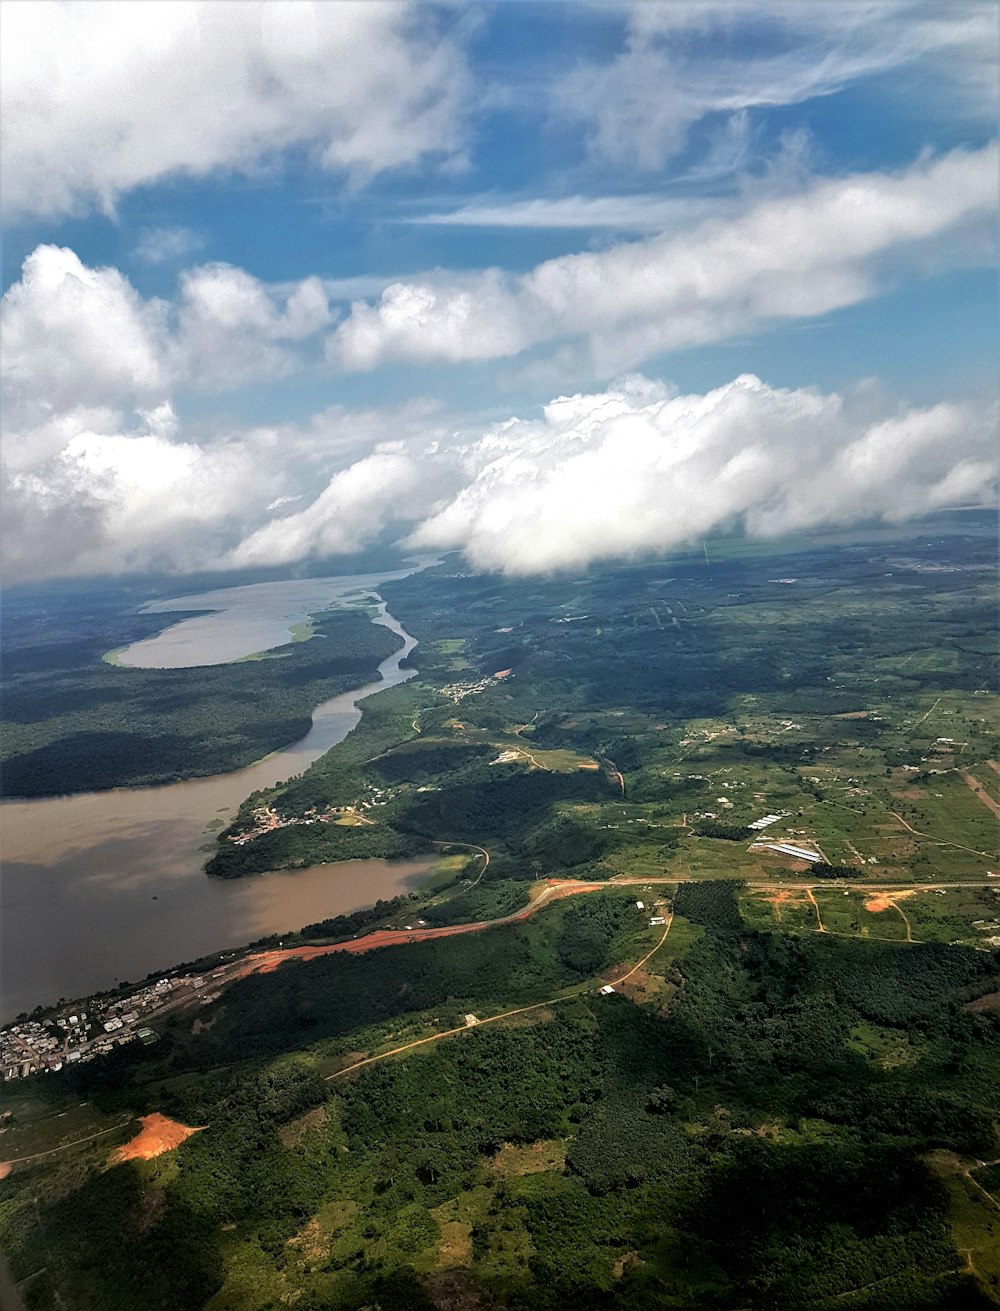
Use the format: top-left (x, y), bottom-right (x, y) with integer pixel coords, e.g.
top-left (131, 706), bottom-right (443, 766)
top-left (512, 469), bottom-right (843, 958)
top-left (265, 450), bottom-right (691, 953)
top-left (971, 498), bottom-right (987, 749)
top-left (409, 375), bottom-right (999, 574)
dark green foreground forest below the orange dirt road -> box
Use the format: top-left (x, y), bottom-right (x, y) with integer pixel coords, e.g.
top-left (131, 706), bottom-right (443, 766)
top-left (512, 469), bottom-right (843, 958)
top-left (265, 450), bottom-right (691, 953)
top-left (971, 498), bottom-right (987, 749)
top-left (0, 882), bottom-right (1000, 1311)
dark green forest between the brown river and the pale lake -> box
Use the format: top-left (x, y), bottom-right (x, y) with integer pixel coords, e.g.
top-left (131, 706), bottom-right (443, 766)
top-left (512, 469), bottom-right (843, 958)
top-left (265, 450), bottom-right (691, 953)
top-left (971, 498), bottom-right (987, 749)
top-left (3, 594), bottom-right (400, 797)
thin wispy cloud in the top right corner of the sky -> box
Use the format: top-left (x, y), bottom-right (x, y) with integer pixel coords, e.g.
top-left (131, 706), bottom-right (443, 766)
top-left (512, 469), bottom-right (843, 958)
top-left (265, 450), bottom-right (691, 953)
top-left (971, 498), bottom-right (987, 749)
top-left (554, 0), bottom-right (997, 169)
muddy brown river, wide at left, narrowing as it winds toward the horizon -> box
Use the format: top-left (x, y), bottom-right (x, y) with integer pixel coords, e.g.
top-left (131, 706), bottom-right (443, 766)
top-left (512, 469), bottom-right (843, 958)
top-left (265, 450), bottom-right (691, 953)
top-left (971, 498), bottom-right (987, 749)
top-left (0, 570), bottom-right (434, 1023)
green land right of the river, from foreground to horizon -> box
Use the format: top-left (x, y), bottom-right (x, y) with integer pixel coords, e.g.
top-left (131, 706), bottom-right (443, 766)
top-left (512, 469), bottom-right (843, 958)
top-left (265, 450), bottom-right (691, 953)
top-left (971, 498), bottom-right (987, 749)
top-left (0, 515), bottom-right (1000, 1311)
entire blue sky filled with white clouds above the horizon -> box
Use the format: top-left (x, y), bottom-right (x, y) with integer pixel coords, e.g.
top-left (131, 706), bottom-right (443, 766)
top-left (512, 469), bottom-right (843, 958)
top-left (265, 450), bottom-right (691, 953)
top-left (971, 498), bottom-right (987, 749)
top-left (0, 0), bottom-right (1000, 582)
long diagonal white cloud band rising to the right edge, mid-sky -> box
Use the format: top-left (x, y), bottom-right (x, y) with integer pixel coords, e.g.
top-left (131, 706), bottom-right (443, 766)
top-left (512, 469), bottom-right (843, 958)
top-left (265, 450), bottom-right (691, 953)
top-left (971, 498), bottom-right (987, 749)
top-left (328, 146), bottom-right (997, 375)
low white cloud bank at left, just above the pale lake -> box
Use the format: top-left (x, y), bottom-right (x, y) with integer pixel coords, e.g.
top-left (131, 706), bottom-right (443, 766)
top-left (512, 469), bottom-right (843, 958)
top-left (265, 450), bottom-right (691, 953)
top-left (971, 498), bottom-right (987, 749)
top-left (0, 374), bottom-right (446, 582)
